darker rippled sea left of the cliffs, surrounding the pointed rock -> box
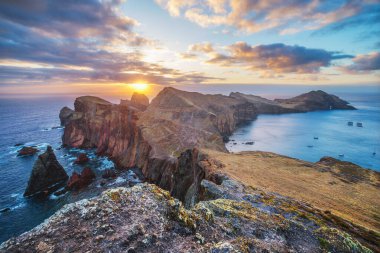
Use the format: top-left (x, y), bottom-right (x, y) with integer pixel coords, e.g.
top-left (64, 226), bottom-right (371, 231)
top-left (0, 97), bottom-right (142, 243)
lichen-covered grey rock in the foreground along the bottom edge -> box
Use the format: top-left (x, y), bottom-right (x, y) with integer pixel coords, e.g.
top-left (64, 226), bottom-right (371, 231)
top-left (0, 183), bottom-right (371, 252)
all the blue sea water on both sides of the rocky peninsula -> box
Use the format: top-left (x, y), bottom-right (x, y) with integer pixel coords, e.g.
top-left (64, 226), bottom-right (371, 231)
top-left (0, 86), bottom-right (380, 243)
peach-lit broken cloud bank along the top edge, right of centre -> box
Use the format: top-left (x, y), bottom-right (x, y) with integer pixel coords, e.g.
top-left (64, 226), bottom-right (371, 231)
top-left (156, 0), bottom-right (378, 34)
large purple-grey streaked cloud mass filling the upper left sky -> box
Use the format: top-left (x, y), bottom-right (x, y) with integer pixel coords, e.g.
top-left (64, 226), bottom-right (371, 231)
top-left (0, 0), bottom-right (211, 84)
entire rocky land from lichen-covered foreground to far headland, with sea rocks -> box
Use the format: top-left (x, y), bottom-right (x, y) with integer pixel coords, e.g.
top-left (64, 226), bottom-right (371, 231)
top-left (0, 88), bottom-right (380, 252)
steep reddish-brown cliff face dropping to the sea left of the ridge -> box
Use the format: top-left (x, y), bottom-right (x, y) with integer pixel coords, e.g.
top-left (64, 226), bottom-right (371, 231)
top-left (62, 96), bottom-right (150, 167)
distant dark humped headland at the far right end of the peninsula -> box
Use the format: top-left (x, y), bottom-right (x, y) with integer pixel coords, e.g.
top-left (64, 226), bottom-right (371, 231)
top-left (275, 90), bottom-right (355, 112)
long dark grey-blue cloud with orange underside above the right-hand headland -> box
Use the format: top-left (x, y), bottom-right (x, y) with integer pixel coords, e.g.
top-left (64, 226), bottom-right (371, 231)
top-left (207, 42), bottom-right (353, 76)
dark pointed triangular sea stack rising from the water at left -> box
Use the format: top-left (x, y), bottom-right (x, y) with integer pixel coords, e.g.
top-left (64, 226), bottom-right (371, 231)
top-left (24, 146), bottom-right (68, 197)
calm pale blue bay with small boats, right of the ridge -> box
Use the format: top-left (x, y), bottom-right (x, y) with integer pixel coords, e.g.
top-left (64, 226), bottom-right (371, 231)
top-left (226, 93), bottom-right (380, 171)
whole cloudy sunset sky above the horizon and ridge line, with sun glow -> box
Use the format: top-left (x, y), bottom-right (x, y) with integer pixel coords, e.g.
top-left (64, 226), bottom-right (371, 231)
top-left (0, 0), bottom-right (380, 98)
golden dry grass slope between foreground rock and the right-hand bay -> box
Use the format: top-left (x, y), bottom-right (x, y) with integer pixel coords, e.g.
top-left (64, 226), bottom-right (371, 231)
top-left (206, 150), bottom-right (380, 232)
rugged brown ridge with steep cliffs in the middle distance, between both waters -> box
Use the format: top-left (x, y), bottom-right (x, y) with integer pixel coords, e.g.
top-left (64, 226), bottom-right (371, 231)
top-left (61, 88), bottom-right (356, 206)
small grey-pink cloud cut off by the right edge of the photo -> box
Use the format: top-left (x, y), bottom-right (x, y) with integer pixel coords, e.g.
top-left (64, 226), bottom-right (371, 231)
top-left (341, 52), bottom-right (380, 74)
